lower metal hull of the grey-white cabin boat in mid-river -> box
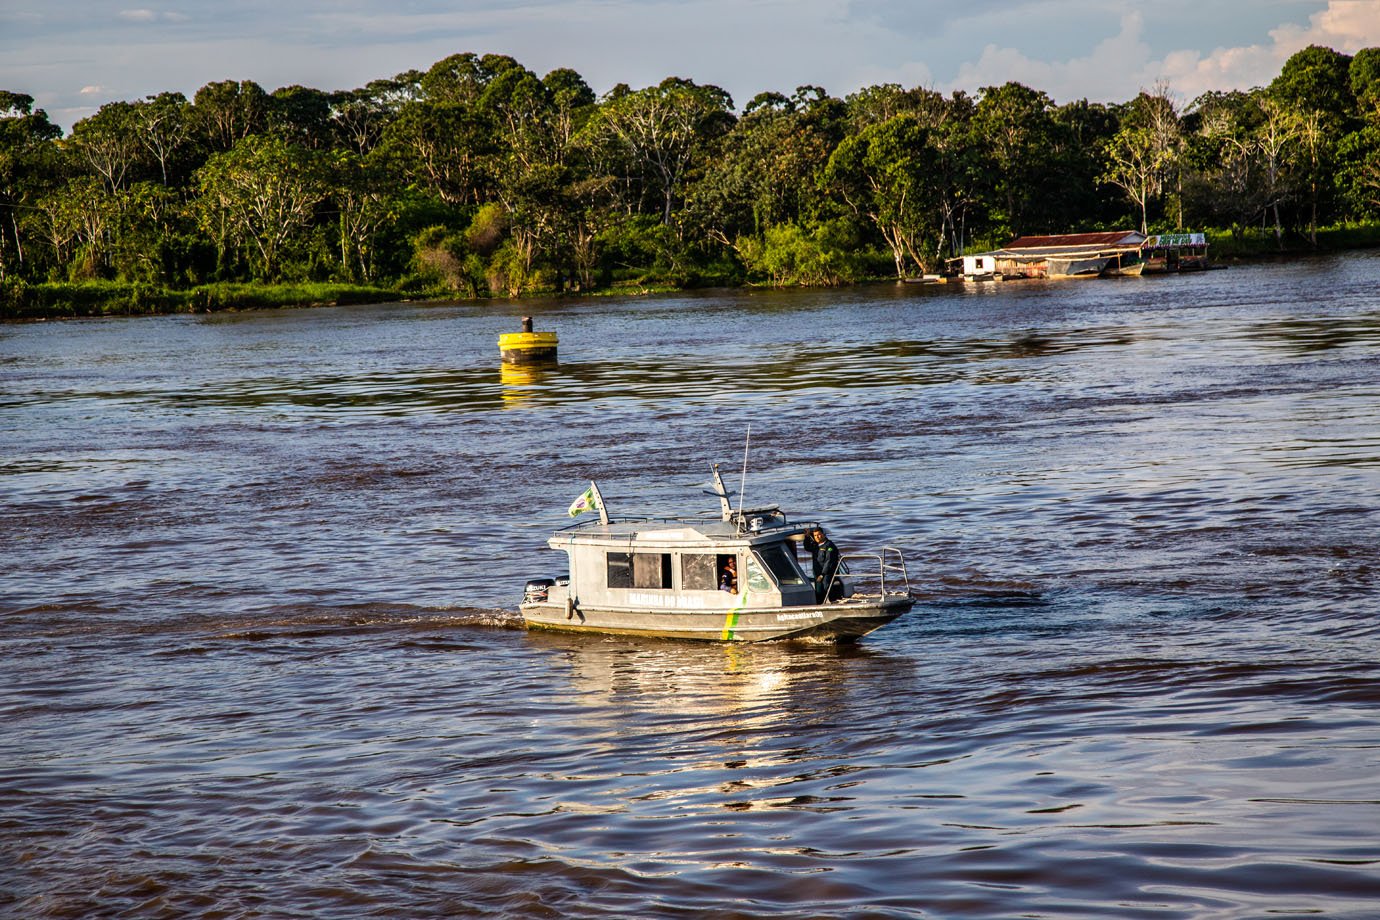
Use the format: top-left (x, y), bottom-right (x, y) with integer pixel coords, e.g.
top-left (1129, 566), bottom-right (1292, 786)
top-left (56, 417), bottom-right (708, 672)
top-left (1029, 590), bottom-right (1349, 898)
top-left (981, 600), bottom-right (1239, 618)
top-left (522, 594), bottom-right (915, 641)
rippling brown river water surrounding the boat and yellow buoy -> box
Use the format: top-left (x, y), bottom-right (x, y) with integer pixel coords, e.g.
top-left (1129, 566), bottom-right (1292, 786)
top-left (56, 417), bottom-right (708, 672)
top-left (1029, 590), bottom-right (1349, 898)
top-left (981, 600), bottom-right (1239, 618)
top-left (0, 252), bottom-right (1380, 920)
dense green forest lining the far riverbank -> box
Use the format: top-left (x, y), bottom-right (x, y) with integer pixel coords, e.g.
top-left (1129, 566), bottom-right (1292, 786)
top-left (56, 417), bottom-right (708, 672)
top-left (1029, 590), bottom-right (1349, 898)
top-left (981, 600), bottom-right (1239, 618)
top-left (0, 46), bottom-right (1380, 319)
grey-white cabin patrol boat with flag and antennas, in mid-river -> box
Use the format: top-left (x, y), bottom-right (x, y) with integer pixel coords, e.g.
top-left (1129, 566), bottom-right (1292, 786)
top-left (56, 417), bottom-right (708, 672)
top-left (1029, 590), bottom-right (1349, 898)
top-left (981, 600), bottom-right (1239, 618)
top-left (522, 466), bottom-right (915, 641)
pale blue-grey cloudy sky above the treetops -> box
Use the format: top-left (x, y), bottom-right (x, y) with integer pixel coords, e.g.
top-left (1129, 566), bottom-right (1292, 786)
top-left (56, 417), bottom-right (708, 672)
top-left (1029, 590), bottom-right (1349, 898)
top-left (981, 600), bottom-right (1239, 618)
top-left (0, 0), bottom-right (1380, 130)
